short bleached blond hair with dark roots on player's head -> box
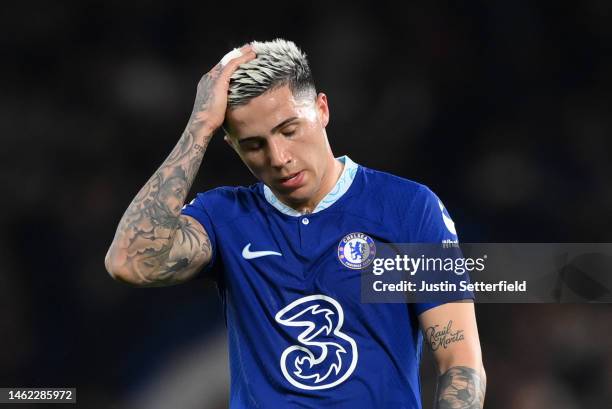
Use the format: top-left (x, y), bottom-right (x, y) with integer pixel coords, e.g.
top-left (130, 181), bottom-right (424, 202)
top-left (228, 38), bottom-right (316, 108)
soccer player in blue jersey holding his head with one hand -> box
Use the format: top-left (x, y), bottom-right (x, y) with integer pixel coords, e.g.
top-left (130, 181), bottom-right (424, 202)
top-left (105, 39), bottom-right (485, 409)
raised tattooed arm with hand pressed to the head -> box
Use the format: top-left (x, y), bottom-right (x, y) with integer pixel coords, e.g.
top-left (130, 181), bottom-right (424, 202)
top-left (105, 46), bottom-right (255, 286)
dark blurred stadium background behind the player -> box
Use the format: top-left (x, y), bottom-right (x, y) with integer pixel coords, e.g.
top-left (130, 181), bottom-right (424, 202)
top-left (0, 0), bottom-right (612, 409)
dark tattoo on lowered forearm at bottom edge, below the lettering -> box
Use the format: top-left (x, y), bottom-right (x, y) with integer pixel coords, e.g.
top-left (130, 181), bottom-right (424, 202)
top-left (435, 366), bottom-right (486, 409)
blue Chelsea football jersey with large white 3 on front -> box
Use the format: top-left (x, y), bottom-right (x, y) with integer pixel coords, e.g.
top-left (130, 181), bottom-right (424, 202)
top-left (183, 156), bottom-right (468, 409)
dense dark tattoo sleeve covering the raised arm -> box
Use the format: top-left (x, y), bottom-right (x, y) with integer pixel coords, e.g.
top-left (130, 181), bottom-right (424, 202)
top-left (114, 66), bottom-right (220, 284)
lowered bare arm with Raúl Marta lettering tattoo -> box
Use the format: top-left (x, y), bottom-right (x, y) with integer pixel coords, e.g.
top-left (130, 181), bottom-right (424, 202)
top-left (419, 302), bottom-right (487, 409)
